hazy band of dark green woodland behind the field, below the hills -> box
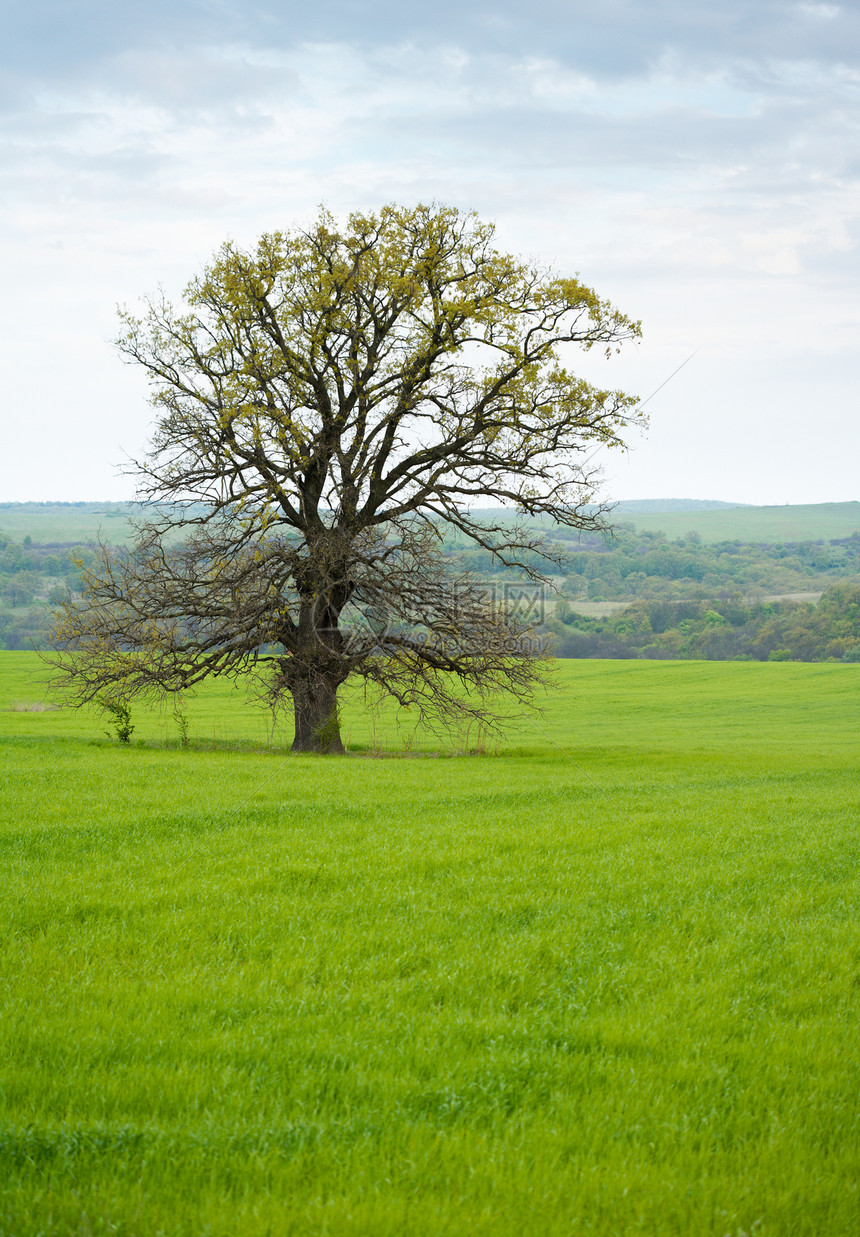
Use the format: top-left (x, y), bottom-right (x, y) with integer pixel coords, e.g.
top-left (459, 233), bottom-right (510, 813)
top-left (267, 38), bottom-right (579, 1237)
top-left (0, 526), bottom-right (860, 662)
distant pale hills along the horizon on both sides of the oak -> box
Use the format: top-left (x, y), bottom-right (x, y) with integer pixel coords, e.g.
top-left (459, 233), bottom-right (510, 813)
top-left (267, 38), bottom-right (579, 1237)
top-left (0, 499), bottom-right (860, 546)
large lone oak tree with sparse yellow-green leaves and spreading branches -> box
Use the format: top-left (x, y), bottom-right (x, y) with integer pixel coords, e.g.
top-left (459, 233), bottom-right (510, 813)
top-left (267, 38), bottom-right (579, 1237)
top-left (47, 205), bottom-right (641, 752)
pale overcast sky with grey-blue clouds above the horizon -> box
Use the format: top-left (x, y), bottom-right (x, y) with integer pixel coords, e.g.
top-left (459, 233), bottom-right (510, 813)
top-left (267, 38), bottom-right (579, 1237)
top-left (0, 0), bottom-right (860, 502)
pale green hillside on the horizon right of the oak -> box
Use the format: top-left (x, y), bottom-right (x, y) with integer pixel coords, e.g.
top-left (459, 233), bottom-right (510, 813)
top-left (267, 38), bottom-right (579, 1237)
top-left (615, 502), bottom-right (860, 543)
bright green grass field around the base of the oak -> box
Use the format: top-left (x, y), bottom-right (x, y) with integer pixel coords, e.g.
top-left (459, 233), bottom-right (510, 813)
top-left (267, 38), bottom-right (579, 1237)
top-left (0, 653), bottom-right (860, 1237)
